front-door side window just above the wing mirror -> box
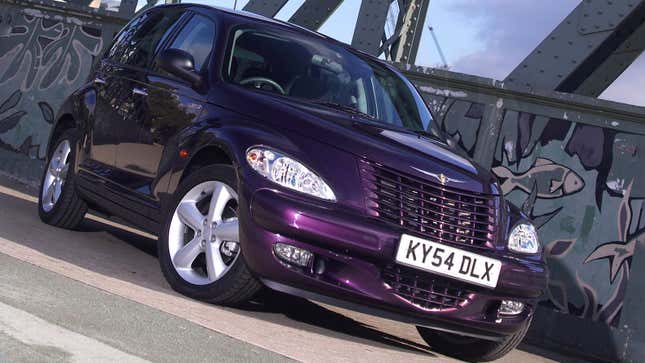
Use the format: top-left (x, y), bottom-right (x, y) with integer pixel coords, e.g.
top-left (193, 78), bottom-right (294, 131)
top-left (169, 15), bottom-right (215, 72)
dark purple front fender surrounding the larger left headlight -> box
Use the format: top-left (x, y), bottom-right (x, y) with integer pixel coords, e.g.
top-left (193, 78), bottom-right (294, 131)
top-left (160, 106), bottom-right (365, 213)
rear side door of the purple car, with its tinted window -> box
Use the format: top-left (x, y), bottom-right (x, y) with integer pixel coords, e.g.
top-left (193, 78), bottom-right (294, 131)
top-left (80, 7), bottom-right (185, 225)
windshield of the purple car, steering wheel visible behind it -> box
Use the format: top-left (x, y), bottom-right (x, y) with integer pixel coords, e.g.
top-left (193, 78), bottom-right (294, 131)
top-left (226, 29), bottom-right (438, 136)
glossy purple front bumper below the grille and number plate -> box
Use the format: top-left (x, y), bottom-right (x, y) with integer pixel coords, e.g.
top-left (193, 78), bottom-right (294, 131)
top-left (240, 188), bottom-right (546, 340)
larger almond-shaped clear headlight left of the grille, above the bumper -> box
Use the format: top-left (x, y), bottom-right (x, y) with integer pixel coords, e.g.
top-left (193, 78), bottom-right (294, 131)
top-left (246, 147), bottom-right (336, 201)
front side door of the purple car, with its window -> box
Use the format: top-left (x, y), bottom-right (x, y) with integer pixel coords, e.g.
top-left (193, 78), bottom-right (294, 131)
top-left (117, 12), bottom-right (216, 219)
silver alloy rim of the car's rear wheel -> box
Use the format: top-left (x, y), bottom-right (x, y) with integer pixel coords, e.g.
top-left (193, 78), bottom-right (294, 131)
top-left (41, 140), bottom-right (72, 212)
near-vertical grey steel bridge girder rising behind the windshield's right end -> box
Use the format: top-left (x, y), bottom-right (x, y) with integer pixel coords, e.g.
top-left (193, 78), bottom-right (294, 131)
top-left (391, 0), bottom-right (430, 64)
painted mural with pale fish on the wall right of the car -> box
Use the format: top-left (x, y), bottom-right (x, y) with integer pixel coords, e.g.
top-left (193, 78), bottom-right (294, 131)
top-left (412, 75), bottom-right (645, 327)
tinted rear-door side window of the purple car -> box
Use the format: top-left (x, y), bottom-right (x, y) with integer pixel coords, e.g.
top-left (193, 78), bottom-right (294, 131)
top-left (107, 10), bottom-right (182, 68)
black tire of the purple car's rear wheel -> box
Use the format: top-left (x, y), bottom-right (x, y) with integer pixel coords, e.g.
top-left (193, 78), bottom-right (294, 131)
top-left (38, 129), bottom-right (87, 229)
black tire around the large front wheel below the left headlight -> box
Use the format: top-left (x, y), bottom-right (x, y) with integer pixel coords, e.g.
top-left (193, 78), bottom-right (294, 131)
top-left (158, 165), bottom-right (262, 306)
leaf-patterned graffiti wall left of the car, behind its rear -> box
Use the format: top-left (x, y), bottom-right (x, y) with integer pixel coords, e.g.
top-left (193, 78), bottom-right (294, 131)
top-left (0, 0), bottom-right (130, 181)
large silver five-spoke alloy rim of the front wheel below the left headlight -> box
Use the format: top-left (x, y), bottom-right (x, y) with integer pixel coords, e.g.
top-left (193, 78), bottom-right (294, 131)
top-left (168, 181), bottom-right (240, 285)
